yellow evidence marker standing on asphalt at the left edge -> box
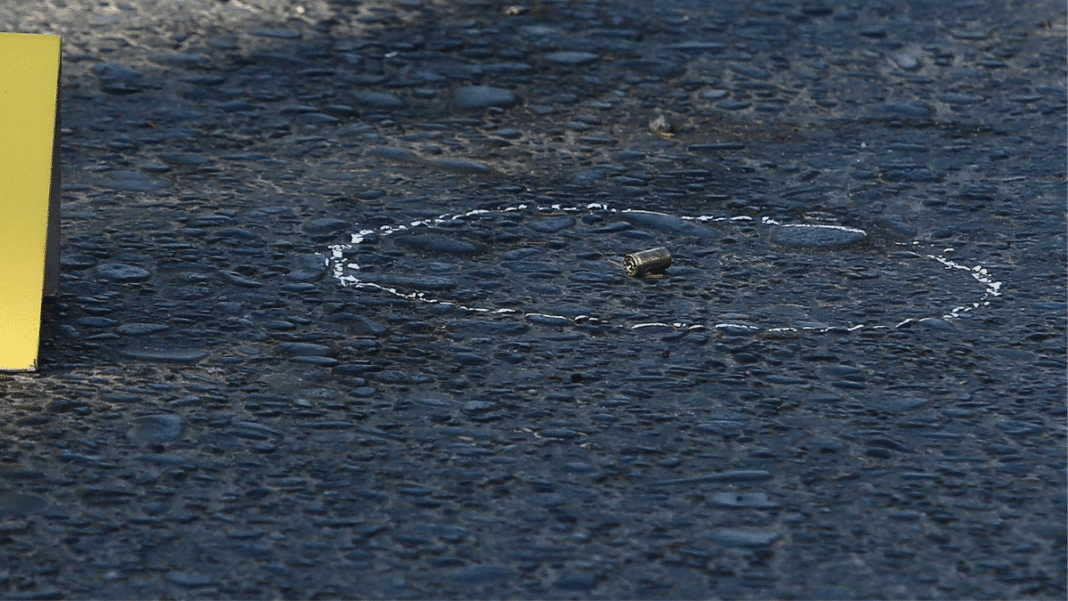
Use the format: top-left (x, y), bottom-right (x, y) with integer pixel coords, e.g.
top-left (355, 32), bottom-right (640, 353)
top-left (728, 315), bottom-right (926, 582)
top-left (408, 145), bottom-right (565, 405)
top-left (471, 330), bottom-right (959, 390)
top-left (0, 33), bottom-right (60, 371)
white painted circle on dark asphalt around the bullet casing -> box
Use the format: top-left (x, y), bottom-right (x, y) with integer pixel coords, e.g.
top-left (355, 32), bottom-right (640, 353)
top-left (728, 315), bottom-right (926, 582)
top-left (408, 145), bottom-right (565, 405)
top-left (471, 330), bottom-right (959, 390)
top-left (325, 203), bottom-right (1003, 335)
